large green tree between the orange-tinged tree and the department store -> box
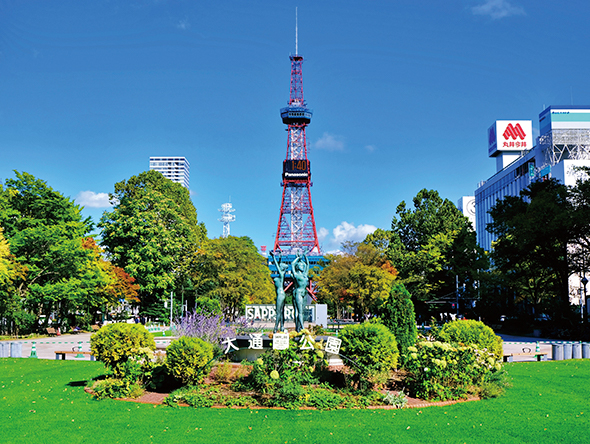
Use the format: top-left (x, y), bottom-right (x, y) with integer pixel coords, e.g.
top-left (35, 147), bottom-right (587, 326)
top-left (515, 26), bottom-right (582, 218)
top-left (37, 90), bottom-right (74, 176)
top-left (387, 189), bottom-right (488, 310)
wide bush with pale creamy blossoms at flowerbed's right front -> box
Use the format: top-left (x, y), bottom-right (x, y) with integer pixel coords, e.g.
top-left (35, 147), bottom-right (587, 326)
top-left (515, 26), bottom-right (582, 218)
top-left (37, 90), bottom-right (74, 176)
top-left (406, 341), bottom-right (502, 401)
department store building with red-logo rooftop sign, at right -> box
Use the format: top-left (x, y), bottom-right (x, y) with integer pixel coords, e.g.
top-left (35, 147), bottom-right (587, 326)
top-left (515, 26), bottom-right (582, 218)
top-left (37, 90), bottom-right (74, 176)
top-left (475, 105), bottom-right (590, 304)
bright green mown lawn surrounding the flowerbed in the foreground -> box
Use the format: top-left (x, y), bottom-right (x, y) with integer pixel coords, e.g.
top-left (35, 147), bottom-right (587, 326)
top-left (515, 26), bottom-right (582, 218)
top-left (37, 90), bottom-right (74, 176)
top-left (0, 358), bottom-right (590, 444)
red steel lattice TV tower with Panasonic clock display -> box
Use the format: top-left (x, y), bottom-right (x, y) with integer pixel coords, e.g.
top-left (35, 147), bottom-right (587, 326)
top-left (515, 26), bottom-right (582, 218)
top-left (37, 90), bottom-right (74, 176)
top-left (274, 25), bottom-right (321, 256)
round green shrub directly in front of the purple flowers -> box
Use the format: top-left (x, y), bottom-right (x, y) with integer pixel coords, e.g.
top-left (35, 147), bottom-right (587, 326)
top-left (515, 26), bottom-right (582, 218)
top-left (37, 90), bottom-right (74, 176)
top-left (166, 336), bottom-right (215, 384)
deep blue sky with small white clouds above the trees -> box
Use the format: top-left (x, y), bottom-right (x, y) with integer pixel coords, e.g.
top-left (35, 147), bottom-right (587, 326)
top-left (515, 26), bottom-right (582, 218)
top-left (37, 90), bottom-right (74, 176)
top-left (0, 0), bottom-right (590, 251)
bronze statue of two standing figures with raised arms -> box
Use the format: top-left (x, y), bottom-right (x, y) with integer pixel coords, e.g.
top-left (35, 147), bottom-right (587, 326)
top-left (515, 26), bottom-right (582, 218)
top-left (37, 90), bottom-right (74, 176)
top-left (270, 251), bottom-right (309, 333)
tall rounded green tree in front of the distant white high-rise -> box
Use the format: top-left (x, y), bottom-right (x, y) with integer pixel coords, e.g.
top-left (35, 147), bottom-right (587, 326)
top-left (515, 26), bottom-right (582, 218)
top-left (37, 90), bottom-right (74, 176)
top-left (98, 170), bottom-right (206, 316)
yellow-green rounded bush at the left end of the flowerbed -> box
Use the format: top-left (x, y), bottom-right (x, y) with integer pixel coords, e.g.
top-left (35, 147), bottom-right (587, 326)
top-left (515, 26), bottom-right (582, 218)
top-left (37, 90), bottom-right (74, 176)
top-left (90, 323), bottom-right (156, 378)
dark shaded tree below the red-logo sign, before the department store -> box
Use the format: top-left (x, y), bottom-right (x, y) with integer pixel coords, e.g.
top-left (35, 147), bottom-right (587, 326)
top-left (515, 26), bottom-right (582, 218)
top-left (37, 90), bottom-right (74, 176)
top-left (487, 179), bottom-right (576, 312)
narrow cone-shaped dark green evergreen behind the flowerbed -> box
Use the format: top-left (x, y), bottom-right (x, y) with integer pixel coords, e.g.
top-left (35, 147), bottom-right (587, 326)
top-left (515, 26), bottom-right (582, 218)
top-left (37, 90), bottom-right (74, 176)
top-left (379, 282), bottom-right (418, 365)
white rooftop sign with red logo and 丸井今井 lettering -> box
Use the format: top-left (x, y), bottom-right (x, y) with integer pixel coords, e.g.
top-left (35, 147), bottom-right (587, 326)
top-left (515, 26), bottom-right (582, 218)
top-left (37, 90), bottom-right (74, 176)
top-left (488, 120), bottom-right (533, 157)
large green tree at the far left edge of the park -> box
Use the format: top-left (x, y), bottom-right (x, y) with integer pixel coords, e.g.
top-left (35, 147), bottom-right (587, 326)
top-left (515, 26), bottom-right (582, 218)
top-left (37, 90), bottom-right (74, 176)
top-left (0, 172), bottom-right (94, 332)
